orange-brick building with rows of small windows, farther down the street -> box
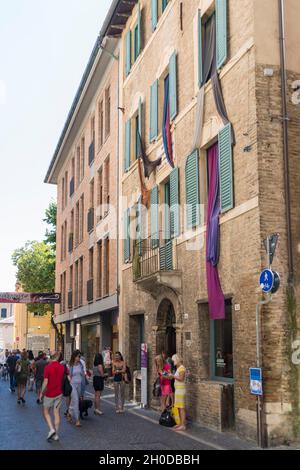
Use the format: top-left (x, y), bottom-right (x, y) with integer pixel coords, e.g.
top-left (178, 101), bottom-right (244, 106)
top-left (46, 33), bottom-right (119, 367)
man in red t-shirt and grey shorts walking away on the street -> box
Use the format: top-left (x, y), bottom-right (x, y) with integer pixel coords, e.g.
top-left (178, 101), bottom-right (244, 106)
top-left (40, 351), bottom-right (69, 441)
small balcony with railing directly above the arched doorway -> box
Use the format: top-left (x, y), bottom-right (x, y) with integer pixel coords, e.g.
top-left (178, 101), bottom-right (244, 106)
top-left (132, 238), bottom-right (182, 295)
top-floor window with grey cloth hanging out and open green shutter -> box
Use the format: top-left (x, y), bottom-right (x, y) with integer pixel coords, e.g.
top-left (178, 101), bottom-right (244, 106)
top-left (198, 0), bottom-right (228, 87)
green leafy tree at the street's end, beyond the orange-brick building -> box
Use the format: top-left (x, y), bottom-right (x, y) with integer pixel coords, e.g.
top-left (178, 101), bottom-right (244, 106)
top-left (12, 202), bottom-right (62, 343)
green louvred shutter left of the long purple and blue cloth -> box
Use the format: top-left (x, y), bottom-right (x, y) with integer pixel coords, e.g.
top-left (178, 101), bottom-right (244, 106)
top-left (185, 150), bottom-right (200, 228)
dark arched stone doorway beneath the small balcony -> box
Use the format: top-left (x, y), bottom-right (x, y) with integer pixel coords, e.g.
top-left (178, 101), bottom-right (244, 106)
top-left (156, 299), bottom-right (176, 356)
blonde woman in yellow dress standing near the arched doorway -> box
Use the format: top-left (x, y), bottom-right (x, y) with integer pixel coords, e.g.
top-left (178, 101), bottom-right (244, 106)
top-left (169, 354), bottom-right (186, 431)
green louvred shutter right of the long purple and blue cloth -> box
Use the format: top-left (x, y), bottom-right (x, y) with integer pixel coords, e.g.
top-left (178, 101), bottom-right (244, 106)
top-left (219, 123), bottom-right (233, 213)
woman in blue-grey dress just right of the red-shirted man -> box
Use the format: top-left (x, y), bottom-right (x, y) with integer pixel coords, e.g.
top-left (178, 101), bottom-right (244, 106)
top-left (68, 349), bottom-right (86, 427)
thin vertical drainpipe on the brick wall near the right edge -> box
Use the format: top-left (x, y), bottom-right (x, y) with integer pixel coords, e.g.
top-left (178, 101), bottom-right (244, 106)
top-left (278, 0), bottom-right (294, 285)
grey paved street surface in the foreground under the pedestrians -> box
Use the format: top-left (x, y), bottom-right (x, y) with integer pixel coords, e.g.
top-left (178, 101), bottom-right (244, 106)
top-left (0, 380), bottom-right (253, 450)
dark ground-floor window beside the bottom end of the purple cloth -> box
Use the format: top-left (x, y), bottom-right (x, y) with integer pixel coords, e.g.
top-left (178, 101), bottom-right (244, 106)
top-left (210, 300), bottom-right (234, 380)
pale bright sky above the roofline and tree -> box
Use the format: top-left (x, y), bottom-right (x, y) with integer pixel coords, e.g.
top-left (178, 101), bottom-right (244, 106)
top-left (0, 0), bottom-right (111, 292)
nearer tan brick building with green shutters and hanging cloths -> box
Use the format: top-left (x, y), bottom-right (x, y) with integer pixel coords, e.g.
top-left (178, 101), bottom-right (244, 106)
top-left (111, 0), bottom-right (300, 444)
